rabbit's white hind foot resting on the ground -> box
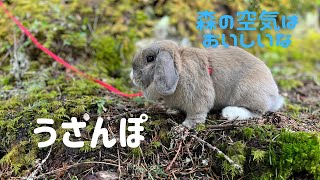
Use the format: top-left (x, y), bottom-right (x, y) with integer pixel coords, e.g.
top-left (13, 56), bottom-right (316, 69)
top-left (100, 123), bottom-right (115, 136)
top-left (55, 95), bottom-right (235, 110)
top-left (222, 106), bottom-right (257, 120)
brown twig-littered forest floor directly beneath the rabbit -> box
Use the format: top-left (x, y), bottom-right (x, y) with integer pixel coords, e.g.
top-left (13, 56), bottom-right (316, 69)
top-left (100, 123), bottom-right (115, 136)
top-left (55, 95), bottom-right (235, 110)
top-left (0, 72), bottom-right (320, 179)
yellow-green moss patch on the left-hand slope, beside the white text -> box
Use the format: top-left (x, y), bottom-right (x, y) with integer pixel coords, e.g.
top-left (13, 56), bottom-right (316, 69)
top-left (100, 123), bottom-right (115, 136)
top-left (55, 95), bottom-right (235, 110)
top-left (0, 69), bottom-right (109, 175)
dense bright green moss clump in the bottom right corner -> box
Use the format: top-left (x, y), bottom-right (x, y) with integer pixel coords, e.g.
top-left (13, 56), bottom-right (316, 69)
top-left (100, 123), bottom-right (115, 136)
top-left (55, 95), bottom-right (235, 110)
top-left (270, 131), bottom-right (320, 179)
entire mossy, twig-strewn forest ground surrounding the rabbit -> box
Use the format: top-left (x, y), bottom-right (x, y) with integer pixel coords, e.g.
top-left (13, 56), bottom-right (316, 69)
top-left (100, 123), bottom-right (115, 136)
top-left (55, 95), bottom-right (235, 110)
top-left (0, 0), bottom-right (320, 180)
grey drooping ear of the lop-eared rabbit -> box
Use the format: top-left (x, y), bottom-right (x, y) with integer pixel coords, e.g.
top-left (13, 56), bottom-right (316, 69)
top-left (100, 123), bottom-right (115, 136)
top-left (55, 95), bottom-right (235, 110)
top-left (154, 51), bottom-right (179, 95)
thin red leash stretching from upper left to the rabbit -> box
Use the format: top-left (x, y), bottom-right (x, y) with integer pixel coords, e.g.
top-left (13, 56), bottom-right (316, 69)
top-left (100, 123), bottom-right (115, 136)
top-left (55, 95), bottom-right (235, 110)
top-left (0, 0), bottom-right (142, 97)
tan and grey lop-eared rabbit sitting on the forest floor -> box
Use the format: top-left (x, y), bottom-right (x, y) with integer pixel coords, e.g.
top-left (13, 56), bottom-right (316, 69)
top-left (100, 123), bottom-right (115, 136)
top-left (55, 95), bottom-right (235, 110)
top-left (130, 40), bottom-right (284, 128)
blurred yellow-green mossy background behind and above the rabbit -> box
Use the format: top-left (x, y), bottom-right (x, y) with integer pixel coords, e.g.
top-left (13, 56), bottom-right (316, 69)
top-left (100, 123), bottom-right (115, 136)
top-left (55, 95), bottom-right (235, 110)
top-left (0, 0), bottom-right (320, 78)
